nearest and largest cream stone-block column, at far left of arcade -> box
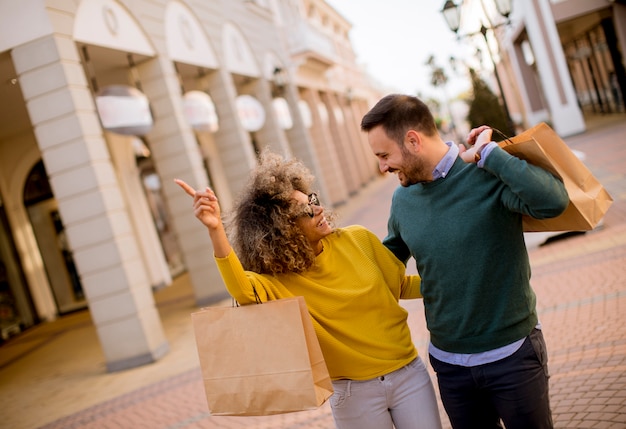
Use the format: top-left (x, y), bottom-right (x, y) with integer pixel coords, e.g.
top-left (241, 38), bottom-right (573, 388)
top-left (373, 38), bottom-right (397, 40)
top-left (11, 36), bottom-right (169, 371)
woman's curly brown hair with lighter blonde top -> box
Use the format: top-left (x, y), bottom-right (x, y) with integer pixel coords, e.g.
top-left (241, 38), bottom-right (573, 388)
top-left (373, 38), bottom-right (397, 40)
top-left (228, 150), bottom-right (334, 275)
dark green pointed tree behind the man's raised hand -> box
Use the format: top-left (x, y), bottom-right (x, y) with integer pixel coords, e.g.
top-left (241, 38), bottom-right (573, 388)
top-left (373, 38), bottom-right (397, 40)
top-left (467, 69), bottom-right (508, 133)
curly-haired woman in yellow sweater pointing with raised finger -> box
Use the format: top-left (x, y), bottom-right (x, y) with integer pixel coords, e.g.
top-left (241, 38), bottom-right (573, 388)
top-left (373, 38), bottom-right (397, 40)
top-left (176, 152), bottom-right (441, 429)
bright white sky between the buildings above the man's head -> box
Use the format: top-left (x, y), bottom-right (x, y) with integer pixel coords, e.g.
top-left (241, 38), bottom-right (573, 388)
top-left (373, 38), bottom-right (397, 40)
top-left (326, 0), bottom-right (476, 99)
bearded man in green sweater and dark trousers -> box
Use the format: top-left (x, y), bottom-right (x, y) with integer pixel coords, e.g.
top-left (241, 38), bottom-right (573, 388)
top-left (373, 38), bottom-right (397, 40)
top-left (361, 94), bottom-right (569, 429)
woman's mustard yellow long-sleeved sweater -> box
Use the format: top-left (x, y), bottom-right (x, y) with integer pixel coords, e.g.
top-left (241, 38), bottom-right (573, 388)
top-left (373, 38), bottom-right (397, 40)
top-left (215, 225), bottom-right (421, 380)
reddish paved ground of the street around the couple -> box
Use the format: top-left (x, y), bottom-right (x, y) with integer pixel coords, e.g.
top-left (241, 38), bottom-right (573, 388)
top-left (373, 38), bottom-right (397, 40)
top-left (0, 116), bottom-right (626, 429)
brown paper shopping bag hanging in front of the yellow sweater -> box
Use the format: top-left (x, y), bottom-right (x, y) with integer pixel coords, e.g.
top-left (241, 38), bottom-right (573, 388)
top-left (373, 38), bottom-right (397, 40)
top-left (191, 296), bottom-right (333, 416)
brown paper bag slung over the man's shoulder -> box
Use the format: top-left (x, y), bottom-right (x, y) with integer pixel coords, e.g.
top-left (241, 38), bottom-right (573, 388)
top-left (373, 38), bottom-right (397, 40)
top-left (494, 122), bottom-right (613, 232)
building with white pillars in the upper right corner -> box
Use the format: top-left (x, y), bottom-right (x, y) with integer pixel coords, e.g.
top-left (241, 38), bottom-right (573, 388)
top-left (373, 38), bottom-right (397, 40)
top-left (456, 0), bottom-right (626, 137)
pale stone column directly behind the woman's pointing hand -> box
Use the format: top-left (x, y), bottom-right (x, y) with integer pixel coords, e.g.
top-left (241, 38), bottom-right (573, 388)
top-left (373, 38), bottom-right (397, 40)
top-left (137, 57), bottom-right (228, 306)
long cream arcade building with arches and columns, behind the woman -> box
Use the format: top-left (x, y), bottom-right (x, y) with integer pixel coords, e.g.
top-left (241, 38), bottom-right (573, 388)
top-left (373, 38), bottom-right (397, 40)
top-left (0, 0), bottom-right (379, 371)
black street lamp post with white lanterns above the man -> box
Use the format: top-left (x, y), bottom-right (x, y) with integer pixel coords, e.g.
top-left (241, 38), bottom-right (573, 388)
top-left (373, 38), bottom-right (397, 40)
top-left (441, 0), bottom-right (515, 136)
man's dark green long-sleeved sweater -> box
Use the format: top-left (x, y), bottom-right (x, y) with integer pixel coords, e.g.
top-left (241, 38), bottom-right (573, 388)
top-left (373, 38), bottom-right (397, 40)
top-left (383, 147), bottom-right (569, 353)
